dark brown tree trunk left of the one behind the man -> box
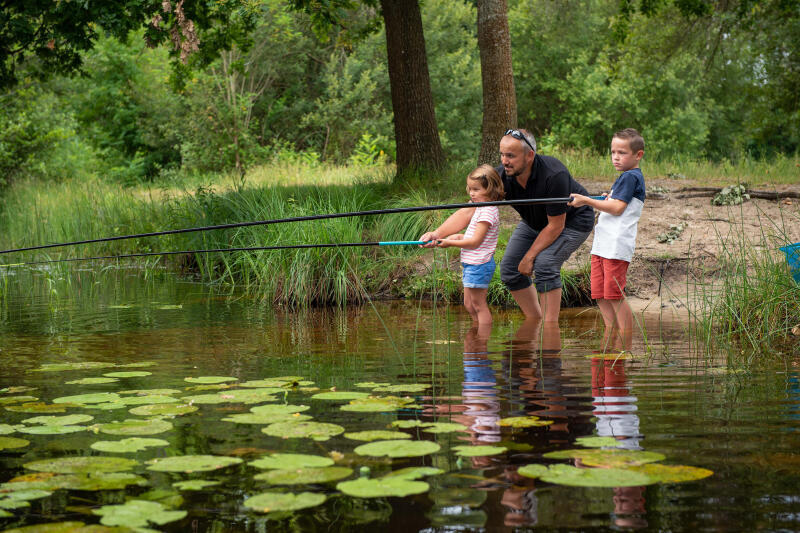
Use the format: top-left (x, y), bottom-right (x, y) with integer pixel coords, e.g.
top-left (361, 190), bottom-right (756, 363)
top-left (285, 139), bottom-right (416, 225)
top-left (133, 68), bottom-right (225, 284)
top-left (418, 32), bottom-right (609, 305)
top-left (381, 0), bottom-right (444, 176)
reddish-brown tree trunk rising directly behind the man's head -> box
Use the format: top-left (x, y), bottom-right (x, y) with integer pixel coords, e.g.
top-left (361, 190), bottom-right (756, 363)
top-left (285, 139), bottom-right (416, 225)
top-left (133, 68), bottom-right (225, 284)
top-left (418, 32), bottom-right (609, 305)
top-left (478, 0), bottom-right (517, 165)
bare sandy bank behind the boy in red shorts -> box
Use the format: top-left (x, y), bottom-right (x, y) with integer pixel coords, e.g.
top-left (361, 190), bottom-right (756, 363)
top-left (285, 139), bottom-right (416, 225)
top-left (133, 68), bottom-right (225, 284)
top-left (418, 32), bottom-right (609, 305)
top-left (556, 179), bottom-right (800, 313)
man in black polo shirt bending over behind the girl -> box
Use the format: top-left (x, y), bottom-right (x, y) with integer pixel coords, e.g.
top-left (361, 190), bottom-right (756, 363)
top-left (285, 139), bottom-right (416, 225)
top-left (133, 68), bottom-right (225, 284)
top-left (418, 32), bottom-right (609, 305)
top-left (420, 130), bottom-right (594, 322)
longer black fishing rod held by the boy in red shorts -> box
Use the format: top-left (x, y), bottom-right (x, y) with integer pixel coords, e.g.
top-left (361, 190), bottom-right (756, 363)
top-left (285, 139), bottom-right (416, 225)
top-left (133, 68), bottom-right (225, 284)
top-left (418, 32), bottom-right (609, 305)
top-left (0, 196), bottom-right (603, 254)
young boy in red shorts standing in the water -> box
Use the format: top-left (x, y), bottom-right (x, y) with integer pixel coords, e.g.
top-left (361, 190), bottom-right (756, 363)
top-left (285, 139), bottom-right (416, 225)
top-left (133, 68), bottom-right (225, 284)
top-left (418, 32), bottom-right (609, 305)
top-left (568, 128), bottom-right (645, 349)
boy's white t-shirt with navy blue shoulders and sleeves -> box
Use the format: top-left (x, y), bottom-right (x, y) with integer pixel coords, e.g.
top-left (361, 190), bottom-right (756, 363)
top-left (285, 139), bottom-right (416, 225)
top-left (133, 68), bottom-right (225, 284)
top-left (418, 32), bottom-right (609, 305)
top-left (591, 168), bottom-right (645, 262)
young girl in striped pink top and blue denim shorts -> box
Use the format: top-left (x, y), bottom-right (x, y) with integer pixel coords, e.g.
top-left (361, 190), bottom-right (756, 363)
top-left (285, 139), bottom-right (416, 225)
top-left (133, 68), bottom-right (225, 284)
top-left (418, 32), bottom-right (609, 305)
top-left (436, 165), bottom-right (505, 324)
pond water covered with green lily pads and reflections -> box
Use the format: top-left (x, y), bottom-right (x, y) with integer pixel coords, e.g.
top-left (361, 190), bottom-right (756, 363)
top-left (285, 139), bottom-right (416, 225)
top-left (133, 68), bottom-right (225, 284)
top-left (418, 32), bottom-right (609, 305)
top-left (0, 270), bottom-right (800, 532)
